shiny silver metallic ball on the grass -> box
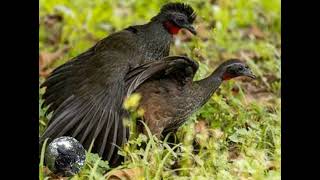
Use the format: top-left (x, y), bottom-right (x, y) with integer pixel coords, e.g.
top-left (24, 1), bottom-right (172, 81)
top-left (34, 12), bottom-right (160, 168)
top-left (45, 136), bottom-right (86, 176)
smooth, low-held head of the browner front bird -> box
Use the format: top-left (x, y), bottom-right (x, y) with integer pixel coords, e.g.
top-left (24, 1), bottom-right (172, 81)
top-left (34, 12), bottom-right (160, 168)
top-left (220, 59), bottom-right (256, 80)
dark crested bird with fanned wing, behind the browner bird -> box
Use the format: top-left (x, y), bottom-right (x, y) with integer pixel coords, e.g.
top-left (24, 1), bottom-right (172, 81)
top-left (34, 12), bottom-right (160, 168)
top-left (39, 3), bottom-right (196, 167)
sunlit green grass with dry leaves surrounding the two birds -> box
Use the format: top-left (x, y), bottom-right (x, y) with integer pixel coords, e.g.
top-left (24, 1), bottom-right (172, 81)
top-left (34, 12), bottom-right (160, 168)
top-left (39, 0), bottom-right (281, 180)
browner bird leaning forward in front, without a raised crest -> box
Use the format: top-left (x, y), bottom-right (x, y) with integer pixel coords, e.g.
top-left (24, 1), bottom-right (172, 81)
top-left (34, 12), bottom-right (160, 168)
top-left (134, 56), bottom-right (256, 138)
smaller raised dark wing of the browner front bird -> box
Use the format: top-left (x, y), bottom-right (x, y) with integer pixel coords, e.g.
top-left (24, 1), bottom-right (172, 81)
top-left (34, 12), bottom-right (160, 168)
top-left (125, 56), bottom-right (199, 94)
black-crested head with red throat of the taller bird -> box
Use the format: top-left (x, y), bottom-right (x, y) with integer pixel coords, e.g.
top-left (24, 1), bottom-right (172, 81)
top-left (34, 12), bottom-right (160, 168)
top-left (151, 3), bottom-right (197, 35)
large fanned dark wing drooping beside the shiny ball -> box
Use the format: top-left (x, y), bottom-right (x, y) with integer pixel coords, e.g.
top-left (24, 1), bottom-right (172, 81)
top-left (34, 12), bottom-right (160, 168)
top-left (40, 29), bottom-right (140, 166)
